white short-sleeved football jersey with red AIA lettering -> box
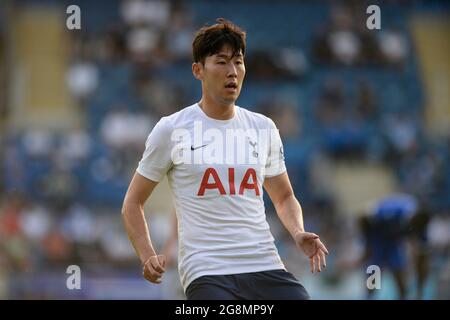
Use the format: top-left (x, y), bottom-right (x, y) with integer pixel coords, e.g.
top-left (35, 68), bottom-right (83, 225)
top-left (137, 104), bottom-right (286, 290)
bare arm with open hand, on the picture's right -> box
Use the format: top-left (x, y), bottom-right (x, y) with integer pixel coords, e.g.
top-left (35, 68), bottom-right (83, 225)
top-left (264, 172), bottom-right (328, 273)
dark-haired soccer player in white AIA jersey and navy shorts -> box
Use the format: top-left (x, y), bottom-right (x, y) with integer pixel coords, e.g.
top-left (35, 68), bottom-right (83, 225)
top-left (122, 19), bottom-right (328, 299)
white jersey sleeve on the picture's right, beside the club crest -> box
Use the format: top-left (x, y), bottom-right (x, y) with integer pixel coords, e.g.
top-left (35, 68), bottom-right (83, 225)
top-left (265, 119), bottom-right (286, 177)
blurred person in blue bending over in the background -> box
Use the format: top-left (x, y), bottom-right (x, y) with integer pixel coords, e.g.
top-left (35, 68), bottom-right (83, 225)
top-left (359, 193), bottom-right (430, 299)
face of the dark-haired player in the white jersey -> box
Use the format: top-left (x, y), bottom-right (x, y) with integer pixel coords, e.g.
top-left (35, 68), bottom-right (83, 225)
top-left (197, 45), bottom-right (245, 104)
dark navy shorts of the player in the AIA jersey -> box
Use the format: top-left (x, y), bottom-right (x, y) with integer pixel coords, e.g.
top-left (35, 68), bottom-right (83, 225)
top-left (186, 270), bottom-right (310, 300)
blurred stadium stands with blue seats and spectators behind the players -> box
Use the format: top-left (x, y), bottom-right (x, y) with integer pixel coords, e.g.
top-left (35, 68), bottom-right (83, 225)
top-left (0, 0), bottom-right (450, 299)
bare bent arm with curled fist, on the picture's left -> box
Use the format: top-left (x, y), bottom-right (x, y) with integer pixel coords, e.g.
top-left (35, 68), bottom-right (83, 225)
top-left (122, 173), bottom-right (164, 283)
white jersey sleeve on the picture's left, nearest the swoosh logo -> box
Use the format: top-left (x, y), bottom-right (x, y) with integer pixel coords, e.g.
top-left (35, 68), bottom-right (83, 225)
top-left (136, 118), bottom-right (173, 182)
